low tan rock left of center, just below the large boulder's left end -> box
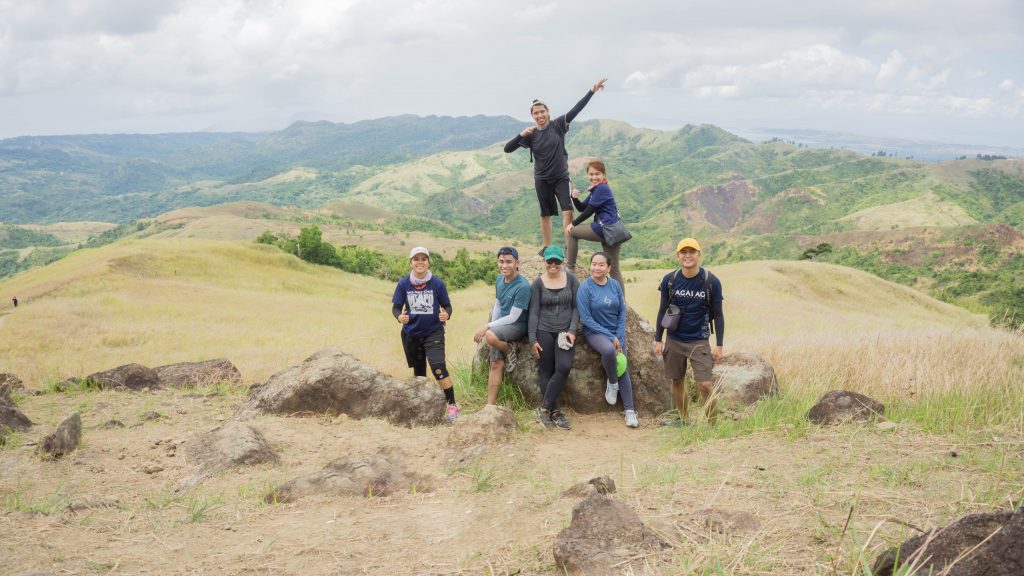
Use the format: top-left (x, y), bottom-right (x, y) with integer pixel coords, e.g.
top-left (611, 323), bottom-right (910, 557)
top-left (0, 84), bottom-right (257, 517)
top-left (177, 416), bottom-right (280, 491)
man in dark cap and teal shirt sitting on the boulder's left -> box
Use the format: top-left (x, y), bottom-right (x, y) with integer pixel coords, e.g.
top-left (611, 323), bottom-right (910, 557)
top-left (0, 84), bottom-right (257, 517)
top-left (473, 246), bottom-right (530, 404)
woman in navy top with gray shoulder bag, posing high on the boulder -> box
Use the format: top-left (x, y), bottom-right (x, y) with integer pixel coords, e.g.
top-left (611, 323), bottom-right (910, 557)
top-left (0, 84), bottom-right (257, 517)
top-left (565, 160), bottom-right (626, 294)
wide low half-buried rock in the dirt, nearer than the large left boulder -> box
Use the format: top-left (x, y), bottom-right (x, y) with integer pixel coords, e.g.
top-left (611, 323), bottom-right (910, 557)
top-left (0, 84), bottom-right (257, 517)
top-left (265, 451), bottom-right (432, 503)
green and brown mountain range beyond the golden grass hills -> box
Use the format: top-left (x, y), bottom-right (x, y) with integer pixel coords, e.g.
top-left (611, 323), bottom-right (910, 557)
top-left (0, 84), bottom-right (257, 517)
top-left (0, 116), bottom-right (1024, 327)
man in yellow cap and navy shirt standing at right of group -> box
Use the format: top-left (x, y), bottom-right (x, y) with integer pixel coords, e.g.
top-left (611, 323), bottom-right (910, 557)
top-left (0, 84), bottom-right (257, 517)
top-left (654, 238), bottom-right (725, 426)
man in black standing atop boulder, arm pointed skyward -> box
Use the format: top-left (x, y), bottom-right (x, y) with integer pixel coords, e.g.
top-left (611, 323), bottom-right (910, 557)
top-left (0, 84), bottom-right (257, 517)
top-left (505, 78), bottom-right (608, 256)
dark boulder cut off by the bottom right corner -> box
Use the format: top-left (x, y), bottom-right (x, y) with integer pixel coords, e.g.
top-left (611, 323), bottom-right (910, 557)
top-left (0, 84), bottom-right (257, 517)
top-left (871, 507), bottom-right (1024, 576)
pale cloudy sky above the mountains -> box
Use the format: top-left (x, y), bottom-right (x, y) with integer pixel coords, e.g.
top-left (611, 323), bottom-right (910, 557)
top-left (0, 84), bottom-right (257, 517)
top-left (0, 0), bottom-right (1024, 147)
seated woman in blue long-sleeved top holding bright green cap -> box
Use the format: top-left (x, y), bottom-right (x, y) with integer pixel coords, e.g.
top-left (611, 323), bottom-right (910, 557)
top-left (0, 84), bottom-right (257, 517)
top-left (577, 252), bottom-right (640, 428)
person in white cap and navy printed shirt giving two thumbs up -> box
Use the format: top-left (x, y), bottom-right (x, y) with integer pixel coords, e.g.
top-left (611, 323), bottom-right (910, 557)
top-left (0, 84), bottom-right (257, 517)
top-left (391, 246), bottom-right (459, 421)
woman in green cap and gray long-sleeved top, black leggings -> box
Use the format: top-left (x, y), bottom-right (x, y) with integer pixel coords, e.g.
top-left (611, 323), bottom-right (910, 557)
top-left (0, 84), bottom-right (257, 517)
top-left (526, 241), bottom-right (580, 430)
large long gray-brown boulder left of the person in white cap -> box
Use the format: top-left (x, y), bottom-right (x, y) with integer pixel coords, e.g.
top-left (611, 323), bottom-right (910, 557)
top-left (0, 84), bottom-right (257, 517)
top-left (236, 349), bottom-right (446, 426)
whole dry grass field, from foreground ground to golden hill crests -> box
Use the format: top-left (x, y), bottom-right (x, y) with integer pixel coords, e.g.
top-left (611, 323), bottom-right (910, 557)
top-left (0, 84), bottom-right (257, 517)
top-left (0, 238), bottom-right (1024, 576)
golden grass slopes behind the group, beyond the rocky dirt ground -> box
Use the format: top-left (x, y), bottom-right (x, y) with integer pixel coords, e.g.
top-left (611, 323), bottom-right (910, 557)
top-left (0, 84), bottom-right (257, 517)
top-left (6, 239), bottom-right (1024, 412)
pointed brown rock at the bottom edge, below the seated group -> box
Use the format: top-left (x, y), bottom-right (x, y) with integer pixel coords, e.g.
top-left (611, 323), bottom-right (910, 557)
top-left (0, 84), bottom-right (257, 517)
top-left (554, 492), bottom-right (669, 576)
